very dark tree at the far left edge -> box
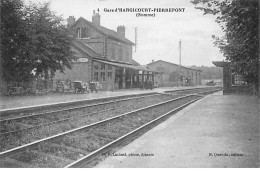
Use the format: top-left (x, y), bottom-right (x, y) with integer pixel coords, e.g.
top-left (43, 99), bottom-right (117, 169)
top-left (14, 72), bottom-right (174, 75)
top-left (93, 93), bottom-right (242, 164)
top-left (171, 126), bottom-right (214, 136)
top-left (0, 0), bottom-right (29, 81)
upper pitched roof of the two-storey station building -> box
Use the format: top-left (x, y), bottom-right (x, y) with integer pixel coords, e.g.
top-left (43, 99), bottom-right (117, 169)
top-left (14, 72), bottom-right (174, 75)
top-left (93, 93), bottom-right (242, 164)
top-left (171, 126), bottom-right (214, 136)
top-left (71, 17), bottom-right (134, 45)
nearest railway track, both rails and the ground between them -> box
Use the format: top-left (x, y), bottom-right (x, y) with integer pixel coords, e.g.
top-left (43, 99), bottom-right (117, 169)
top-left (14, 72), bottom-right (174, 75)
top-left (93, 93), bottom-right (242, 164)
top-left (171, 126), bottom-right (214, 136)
top-left (0, 89), bottom-right (221, 167)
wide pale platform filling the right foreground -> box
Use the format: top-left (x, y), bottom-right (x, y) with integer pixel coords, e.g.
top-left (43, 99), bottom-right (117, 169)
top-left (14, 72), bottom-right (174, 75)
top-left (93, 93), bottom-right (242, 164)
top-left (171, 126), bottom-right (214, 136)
top-left (96, 93), bottom-right (260, 168)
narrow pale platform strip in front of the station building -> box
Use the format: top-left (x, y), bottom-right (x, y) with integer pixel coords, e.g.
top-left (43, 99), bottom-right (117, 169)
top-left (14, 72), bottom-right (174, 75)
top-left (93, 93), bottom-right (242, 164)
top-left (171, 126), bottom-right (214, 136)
top-left (0, 86), bottom-right (205, 110)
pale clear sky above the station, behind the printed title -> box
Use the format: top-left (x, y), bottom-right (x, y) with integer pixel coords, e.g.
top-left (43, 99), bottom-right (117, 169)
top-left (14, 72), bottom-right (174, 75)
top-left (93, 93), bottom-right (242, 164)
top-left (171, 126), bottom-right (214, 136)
top-left (25, 0), bottom-right (224, 66)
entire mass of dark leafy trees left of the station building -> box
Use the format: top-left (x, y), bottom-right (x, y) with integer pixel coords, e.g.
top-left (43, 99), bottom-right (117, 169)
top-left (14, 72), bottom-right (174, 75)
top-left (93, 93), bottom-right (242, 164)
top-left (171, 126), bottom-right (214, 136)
top-left (1, 0), bottom-right (74, 82)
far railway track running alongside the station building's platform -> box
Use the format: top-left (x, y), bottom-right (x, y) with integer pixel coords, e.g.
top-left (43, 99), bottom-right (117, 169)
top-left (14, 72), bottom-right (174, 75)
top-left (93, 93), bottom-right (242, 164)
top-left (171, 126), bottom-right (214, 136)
top-left (0, 94), bottom-right (159, 136)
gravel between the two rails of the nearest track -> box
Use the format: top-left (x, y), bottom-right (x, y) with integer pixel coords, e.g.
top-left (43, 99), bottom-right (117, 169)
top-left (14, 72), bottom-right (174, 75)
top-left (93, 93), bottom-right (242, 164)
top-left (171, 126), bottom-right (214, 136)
top-left (1, 97), bottom-right (197, 167)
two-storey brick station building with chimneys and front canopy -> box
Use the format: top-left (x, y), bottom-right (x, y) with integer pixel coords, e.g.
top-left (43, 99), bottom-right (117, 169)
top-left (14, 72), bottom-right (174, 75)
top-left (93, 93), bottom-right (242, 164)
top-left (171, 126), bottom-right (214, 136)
top-left (54, 11), bottom-right (158, 90)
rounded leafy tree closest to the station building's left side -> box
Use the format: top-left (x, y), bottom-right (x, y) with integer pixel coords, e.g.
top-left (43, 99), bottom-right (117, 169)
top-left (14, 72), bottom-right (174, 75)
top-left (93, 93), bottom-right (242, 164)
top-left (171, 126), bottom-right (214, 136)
top-left (25, 3), bottom-right (74, 79)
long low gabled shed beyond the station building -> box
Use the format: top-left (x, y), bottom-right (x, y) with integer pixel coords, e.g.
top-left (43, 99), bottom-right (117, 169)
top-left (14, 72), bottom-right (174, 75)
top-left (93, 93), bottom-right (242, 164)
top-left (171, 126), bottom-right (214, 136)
top-left (147, 60), bottom-right (202, 86)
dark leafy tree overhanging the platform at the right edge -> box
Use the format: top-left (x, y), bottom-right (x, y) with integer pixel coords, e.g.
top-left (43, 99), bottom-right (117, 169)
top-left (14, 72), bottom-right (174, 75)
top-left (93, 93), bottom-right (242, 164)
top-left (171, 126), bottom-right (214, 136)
top-left (191, 0), bottom-right (259, 91)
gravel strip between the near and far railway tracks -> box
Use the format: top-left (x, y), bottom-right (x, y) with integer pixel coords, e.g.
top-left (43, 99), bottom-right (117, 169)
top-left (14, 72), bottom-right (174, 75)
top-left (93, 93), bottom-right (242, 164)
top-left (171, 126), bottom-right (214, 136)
top-left (0, 95), bottom-right (175, 151)
